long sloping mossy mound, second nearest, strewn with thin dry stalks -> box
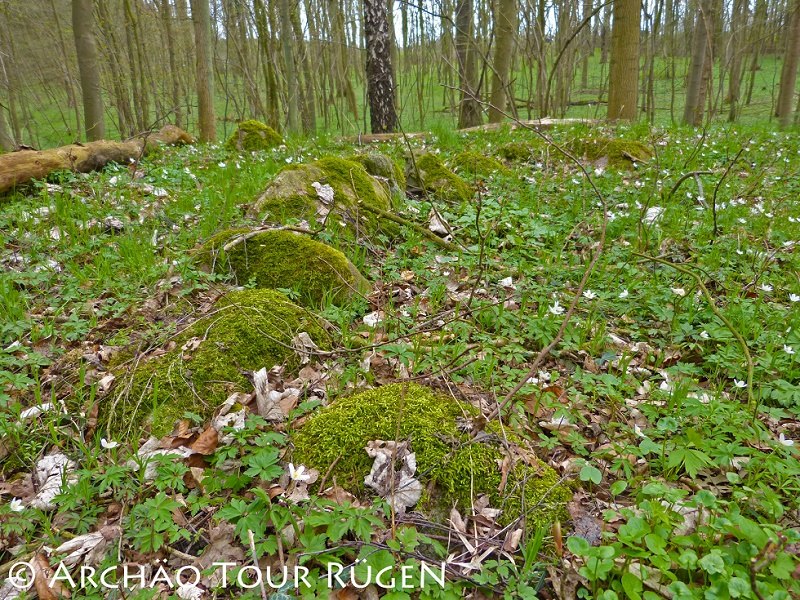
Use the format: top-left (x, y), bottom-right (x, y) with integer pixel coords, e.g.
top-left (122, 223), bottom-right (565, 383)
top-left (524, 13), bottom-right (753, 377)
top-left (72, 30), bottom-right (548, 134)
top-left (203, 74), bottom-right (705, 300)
top-left (106, 290), bottom-right (330, 436)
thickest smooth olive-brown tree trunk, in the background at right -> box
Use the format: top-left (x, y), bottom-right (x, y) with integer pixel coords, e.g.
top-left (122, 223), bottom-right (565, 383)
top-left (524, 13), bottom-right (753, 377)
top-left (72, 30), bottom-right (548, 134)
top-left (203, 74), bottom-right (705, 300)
top-left (608, 0), bottom-right (642, 121)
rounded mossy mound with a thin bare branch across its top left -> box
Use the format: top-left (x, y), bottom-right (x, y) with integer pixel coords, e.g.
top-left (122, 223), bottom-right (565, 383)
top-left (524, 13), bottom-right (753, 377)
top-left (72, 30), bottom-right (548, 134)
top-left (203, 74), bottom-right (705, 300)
top-left (198, 229), bottom-right (369, 307)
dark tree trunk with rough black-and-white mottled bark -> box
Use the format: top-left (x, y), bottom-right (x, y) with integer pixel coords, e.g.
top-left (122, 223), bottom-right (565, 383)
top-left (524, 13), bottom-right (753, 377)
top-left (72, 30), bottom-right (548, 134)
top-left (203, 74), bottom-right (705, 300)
top-left (364, 0), bottom-right (397, 133)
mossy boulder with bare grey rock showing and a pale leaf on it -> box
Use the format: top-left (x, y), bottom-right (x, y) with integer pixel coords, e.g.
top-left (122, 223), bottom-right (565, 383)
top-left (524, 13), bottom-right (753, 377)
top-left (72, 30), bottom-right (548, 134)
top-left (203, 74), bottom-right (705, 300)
top-left (252, 156), bottom-right (392, 232)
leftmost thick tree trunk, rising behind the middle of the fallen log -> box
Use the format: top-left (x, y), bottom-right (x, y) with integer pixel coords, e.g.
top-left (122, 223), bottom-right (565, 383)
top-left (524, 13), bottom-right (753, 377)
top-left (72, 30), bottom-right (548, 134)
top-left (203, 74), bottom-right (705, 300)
top-left (72, 0), bottom-right (105, 141)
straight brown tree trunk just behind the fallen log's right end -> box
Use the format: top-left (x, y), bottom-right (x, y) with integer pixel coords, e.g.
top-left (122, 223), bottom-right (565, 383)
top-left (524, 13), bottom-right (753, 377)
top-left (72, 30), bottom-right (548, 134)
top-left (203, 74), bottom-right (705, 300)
top-left (191, 0), bottom-right (217, 142)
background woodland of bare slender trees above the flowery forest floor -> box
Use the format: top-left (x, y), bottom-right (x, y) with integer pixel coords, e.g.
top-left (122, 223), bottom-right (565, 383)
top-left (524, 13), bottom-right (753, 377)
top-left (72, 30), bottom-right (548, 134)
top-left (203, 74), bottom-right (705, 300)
top-left (0, 0), bottom-right (800, 150)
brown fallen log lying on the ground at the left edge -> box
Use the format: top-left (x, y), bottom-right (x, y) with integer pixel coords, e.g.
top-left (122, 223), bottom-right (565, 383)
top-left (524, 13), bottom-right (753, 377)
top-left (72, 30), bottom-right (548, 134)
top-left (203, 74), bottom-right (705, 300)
top-left (0, 125), bottom-right (194, 194)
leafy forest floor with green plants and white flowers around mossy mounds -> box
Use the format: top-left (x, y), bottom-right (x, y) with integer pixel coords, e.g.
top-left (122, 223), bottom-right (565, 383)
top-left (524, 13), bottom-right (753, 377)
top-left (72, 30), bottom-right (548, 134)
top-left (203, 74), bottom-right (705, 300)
top-left (0, 126), bottom-right (800, 600)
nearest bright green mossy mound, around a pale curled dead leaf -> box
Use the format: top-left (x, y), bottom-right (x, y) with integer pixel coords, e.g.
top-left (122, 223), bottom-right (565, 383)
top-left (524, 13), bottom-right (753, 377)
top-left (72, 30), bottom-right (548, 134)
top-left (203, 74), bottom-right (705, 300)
top-left (292, 384), bottom-right (571, 525)
